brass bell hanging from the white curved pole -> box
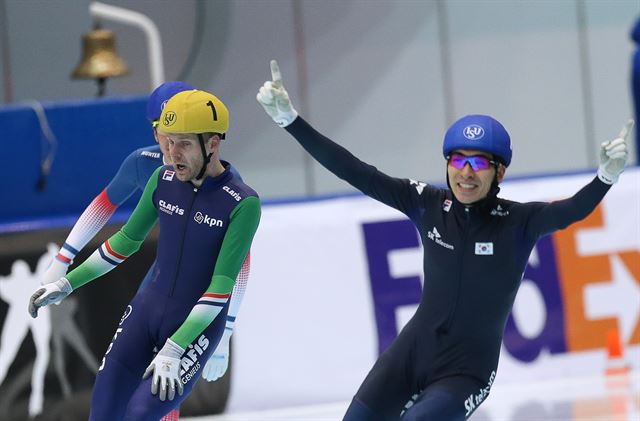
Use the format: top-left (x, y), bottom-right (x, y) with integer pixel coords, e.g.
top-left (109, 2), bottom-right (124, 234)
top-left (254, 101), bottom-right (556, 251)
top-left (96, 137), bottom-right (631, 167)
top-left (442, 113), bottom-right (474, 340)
top-left (71, 29), bottom-right (129, 79)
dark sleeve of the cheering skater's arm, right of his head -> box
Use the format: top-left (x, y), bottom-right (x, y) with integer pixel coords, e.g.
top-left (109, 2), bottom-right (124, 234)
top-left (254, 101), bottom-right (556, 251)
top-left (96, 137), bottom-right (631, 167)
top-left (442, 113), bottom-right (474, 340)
top-left (529, 177), bottom-right (611, 237)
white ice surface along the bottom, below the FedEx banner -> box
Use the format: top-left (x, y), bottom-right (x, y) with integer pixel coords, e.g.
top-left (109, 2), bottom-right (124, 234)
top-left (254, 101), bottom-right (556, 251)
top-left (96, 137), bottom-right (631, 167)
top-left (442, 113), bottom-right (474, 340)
top-left (180, 371), bottom-right (640, 421)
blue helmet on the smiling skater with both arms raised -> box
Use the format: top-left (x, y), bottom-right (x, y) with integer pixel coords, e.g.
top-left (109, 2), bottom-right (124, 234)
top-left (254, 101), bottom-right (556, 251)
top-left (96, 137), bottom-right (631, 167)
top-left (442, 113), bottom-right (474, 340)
top-left (442, 114), bottom-right (512, 167)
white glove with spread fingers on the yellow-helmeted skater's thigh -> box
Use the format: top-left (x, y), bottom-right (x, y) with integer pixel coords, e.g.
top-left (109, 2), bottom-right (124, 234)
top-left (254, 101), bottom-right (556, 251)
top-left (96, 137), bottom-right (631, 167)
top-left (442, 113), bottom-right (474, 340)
top-left (142, 339), bottom-right (184, 402)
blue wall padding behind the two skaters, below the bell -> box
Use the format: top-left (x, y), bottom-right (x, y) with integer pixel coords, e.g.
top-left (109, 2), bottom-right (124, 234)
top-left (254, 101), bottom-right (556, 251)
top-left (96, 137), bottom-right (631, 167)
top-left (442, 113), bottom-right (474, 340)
top-left (0, 95), bottom-right (154, 223)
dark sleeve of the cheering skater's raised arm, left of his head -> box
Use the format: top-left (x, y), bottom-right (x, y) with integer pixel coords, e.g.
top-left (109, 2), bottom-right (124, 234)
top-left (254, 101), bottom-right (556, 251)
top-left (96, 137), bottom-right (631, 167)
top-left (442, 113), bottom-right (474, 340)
top-left (286, 117), bottom-right (425, 219)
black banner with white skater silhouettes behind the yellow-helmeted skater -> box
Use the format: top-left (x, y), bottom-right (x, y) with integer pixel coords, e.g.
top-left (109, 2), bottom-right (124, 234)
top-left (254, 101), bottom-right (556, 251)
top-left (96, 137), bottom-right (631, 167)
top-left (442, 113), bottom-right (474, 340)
top-left (0, 222), bottom-right (231, 421)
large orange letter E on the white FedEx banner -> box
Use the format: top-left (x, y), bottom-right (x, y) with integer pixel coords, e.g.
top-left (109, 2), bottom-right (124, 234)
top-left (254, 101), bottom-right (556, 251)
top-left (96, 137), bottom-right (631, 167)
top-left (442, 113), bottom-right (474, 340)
top-left (553, 205), bottom-right (618, 352)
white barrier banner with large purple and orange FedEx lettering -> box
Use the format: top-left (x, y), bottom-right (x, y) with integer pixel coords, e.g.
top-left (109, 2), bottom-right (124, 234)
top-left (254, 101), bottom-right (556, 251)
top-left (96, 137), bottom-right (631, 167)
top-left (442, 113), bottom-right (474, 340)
top-left (230, 168), bottom-right (640, 409)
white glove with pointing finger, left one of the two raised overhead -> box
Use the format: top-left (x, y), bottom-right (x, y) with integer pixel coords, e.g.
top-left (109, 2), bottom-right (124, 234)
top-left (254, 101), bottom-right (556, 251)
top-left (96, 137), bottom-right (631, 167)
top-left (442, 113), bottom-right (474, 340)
top-left (256, 60), bottom-right (298, 127)
